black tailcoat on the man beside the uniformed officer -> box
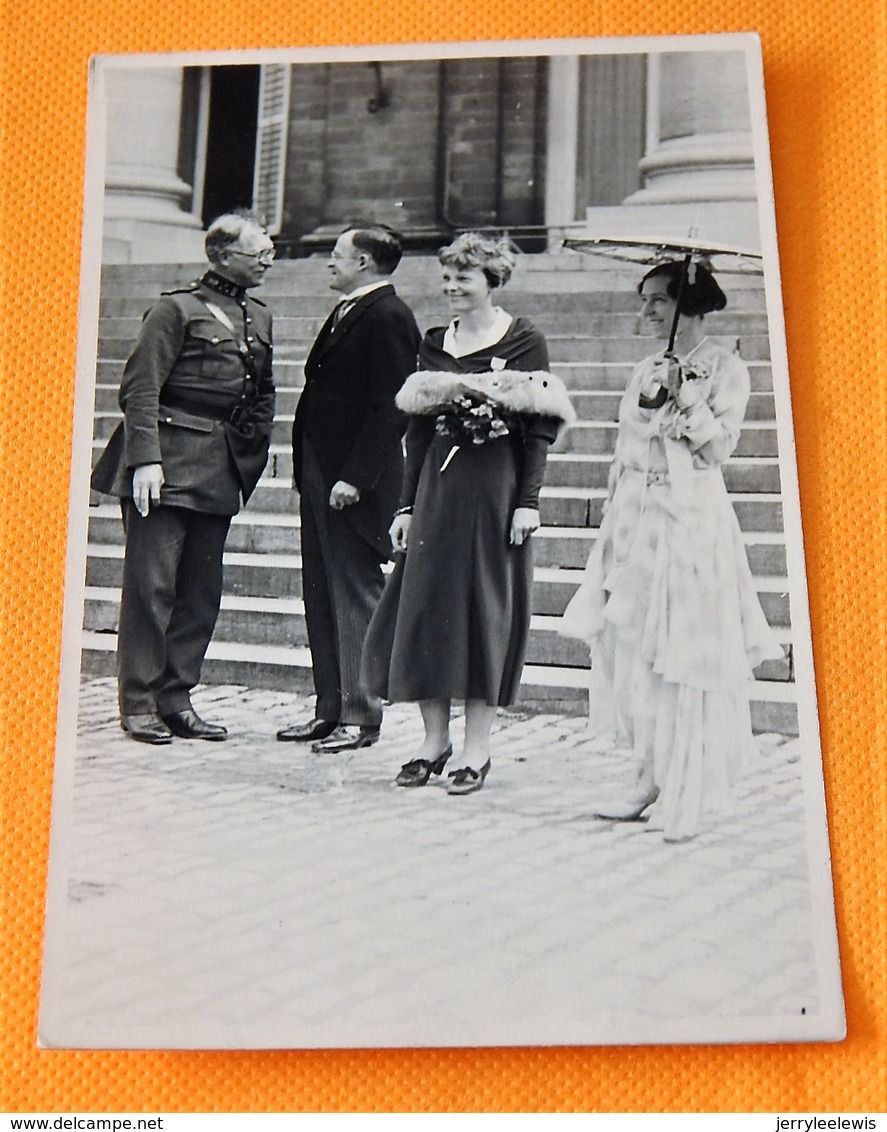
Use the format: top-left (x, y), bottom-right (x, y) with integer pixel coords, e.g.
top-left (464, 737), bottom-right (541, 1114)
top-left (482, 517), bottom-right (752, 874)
top-left (293, 284), bottom-right (421, 557)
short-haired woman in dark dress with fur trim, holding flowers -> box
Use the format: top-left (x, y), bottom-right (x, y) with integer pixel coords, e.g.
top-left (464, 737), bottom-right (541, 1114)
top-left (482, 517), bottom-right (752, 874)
top-left (363, 233), bottom-right (575, 794)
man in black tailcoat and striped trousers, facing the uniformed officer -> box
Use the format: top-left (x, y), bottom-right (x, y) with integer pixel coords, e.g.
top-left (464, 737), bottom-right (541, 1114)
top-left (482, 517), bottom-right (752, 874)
top-left (277, 225), bottom-right (421, 753)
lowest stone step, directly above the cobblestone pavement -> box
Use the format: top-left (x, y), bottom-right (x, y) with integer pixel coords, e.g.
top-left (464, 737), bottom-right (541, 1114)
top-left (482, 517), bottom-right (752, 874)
top-left (81, 631), bottom-right (798, 735)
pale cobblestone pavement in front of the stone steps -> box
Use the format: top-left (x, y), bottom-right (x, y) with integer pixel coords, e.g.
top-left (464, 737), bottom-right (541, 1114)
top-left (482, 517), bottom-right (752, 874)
top-left (41, 679), bottom-right (820, 1047)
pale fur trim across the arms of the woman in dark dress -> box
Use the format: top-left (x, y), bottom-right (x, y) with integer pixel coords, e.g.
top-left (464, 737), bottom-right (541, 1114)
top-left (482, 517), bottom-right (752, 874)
top-left (395, 369), bottom-right (576, 425)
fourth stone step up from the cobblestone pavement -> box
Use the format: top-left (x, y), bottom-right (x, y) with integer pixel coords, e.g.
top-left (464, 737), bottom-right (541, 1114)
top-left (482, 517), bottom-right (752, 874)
top-left (84, 503), bottom-right (786, 575)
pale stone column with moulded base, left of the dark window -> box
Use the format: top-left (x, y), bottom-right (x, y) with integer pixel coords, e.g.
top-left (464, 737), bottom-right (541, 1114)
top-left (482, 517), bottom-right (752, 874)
top-left (103, 67), bottom-right (204, 263)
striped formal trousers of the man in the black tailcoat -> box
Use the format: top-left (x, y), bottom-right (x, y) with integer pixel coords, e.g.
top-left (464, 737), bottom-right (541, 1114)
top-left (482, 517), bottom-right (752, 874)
top-left (300, 449), bottom-right (385, 727)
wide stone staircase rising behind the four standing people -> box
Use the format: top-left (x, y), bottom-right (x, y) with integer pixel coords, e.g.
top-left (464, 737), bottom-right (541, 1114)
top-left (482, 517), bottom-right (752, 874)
top-left (83, 252), bottom-right (798, 734)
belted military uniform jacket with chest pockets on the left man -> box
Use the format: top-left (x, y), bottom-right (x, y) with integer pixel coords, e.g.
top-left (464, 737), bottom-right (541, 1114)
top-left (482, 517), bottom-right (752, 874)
top-left (92, 272), bottom-right (275, 515)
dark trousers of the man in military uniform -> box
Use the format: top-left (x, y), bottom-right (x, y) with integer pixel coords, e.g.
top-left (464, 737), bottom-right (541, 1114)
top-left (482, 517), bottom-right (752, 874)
top-left (117, 499), bottom-right (231, 715)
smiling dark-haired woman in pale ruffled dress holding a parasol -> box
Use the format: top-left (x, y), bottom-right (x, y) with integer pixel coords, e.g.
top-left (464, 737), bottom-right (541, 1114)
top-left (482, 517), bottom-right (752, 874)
top-left (561, 256), bottom-right (783, 840)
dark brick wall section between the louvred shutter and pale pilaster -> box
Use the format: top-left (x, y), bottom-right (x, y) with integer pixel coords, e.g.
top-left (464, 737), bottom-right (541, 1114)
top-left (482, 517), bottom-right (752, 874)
top-left (284, 59), bottom-right (546, 247)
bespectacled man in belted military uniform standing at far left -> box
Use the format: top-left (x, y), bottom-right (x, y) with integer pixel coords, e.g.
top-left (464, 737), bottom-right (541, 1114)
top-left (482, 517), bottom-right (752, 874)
top-left (92, 212), bottom-right (275, 744)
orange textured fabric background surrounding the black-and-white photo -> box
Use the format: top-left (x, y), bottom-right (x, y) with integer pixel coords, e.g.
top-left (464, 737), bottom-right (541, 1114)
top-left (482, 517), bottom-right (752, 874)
top-left (0, 0), bottom-right (887, 1112)
